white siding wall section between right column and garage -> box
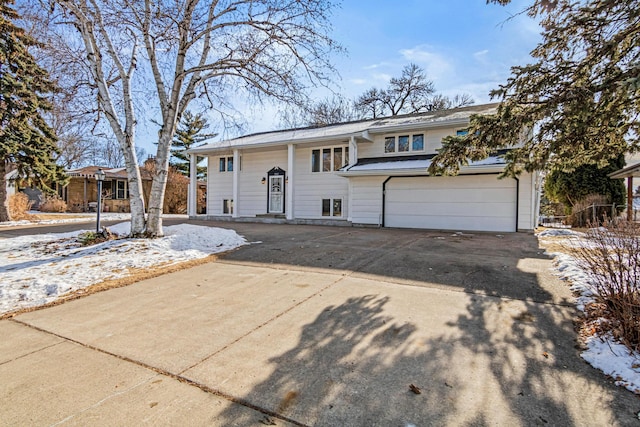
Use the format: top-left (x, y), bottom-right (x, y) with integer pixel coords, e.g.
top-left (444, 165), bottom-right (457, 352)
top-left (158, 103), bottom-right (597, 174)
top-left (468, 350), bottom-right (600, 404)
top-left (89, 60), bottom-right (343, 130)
top-left (294, 147), bottom-right (349, 220)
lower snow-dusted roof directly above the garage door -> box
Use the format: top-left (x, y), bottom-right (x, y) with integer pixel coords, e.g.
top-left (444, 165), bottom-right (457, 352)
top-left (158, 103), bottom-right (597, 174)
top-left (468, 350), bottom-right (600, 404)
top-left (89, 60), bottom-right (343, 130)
top-left (337, 154), bottom-right (506, 176)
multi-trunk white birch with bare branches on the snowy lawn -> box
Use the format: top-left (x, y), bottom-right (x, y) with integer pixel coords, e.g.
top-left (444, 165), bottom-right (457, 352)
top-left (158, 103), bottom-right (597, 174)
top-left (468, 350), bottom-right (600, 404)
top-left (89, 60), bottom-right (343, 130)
top-left (51, 0), bottom-right (341, 237)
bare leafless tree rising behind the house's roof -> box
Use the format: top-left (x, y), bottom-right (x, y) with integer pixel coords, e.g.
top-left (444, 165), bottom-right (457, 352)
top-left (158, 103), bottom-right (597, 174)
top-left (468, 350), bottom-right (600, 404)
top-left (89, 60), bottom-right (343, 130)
top-left (355, 64), bottom-right (474, 119)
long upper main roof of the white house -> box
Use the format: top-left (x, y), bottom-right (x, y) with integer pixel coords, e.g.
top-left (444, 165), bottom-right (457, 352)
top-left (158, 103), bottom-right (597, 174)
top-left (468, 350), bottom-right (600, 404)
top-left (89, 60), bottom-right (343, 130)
top-left (187, 103), bottom-right (498, 154)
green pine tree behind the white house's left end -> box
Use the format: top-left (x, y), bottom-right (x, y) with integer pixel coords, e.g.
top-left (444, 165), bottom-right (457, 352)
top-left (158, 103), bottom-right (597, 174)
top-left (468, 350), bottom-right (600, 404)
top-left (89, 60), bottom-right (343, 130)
top-left (171, 111), bottom-right (216, 179)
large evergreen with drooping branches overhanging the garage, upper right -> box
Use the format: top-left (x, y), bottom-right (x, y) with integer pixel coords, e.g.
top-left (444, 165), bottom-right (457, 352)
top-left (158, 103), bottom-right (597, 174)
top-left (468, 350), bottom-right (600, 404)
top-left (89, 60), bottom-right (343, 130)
top-left (430, 0), bottom-right (640, 175)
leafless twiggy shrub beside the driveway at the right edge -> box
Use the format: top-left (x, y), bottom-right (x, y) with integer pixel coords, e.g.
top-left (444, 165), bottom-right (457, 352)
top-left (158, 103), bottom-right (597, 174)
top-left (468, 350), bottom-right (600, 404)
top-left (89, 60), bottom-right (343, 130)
top-left (574, 221), bottom-right (640, 351)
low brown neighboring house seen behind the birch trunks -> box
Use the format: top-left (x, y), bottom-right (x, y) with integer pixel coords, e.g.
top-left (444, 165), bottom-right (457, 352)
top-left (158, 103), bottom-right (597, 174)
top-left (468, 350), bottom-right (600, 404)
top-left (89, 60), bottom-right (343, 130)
top-left (63, 166), bottom-right (152, 212)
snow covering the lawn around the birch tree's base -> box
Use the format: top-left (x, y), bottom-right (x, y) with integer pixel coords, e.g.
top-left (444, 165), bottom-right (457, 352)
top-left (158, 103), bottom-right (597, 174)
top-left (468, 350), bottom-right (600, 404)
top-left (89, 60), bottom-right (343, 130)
top-left (0, 222), bottom-right (247, 314)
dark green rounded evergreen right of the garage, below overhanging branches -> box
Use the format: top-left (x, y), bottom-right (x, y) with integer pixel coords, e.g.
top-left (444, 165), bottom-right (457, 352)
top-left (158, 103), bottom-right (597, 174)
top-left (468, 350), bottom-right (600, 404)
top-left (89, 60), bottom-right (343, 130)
top-left (544, 155), bottom-right (626, 209)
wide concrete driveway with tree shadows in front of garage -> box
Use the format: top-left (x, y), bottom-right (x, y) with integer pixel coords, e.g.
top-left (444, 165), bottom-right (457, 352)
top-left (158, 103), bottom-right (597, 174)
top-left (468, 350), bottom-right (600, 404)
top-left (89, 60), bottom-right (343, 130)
top-left (0, 222), bottom-right (640, 426)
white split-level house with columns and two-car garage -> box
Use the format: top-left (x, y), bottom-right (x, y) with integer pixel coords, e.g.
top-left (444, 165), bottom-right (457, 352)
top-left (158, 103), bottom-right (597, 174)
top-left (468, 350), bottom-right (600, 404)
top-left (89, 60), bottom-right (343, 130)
top-left (189, 104), bottom-right (539, 232)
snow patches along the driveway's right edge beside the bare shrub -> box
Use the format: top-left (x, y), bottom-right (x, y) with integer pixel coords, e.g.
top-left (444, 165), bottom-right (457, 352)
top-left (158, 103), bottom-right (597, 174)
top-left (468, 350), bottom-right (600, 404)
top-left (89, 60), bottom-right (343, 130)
top-left (537, 229), bottom-right (640, 394)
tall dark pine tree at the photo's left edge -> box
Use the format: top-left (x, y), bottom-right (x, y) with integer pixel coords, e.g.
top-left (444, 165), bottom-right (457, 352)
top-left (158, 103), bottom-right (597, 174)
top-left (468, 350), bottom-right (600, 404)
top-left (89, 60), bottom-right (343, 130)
top-left (0, 0), bottom-right (64, 222)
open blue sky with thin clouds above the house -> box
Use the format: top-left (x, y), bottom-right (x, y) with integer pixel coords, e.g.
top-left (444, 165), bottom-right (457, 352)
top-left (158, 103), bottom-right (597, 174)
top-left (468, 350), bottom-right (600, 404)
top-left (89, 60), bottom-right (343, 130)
top-left (139, 0), bottom-right (540, 153)
